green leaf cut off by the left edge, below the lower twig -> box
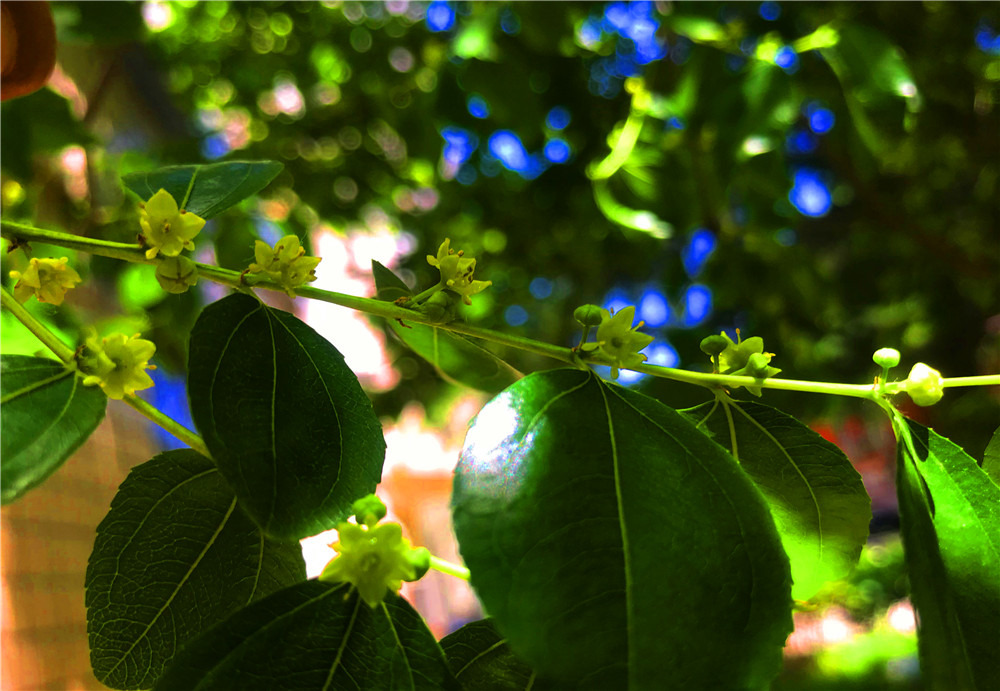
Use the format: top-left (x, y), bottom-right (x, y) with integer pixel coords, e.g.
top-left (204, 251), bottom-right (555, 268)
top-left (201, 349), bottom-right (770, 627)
top-left (0, 355), bottom-right (108, 504)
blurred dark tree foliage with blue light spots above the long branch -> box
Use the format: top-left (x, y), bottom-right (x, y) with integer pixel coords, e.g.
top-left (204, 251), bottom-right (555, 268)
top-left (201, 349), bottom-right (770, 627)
top-left (2, 1), bottom-right (1000, 455)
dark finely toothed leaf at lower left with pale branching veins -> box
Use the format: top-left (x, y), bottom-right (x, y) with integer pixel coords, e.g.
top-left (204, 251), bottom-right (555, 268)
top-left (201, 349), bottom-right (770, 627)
top-left (86, 449), bottom-right (306, 689)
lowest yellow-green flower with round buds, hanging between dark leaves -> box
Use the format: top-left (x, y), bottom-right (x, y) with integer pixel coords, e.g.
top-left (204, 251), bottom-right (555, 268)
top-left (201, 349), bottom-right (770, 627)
top-left (319, 494), bottom-right (430, 608)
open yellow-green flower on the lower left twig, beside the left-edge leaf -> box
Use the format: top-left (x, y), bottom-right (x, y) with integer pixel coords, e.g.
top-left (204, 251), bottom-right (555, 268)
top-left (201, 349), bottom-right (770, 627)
top-left (78, 333), bottom-right (156, 400)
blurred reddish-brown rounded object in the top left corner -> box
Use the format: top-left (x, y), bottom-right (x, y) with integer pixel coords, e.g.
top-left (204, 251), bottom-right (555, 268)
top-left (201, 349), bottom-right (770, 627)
top-left (0, 0), bottom-right (56, 101)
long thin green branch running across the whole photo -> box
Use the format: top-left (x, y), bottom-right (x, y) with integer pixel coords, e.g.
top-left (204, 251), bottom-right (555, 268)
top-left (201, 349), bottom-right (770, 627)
top-left (0, 221), bottom-right (1000, 402)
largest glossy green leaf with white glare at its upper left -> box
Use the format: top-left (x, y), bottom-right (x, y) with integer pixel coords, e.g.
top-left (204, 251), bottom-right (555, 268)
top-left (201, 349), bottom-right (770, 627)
top-left (452, 370), bottom-right (792, 689)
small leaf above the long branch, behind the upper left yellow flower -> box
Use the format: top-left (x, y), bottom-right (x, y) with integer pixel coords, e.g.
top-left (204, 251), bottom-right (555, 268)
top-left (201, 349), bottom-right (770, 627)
top-left (122, 161), bottom-right (284, 219)
